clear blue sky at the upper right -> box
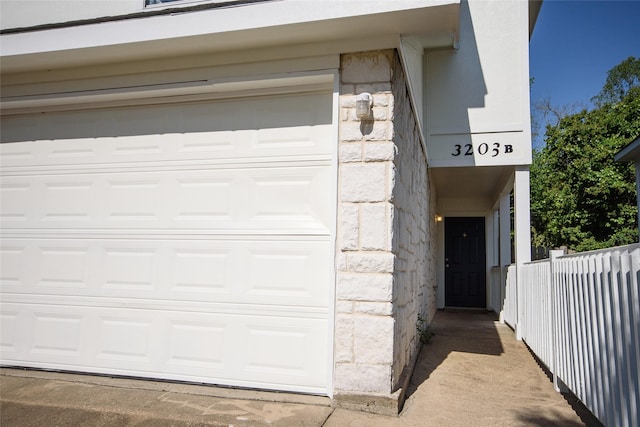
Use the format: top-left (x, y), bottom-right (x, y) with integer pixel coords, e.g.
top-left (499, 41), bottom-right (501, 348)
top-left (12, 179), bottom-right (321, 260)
top-left (529, 0), bottom-right (640, 112)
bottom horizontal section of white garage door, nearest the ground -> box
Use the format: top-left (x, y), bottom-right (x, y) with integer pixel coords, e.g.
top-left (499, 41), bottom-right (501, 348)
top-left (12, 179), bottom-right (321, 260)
top-left (1, 303), bottom-right (327, 392)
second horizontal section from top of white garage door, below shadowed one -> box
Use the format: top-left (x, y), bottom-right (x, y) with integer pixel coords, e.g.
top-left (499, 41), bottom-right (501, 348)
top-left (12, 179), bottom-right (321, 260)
top-left (0, 165), bottom-right (331, 234)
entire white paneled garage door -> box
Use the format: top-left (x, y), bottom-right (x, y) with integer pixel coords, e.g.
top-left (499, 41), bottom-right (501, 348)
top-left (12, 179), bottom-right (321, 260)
top-left (1, 92), bottom-right (335, 393)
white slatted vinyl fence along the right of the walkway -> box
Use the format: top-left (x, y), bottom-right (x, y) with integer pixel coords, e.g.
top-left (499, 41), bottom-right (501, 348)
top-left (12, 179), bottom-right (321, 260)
top-left (503, 244), bottom-right (640, 427)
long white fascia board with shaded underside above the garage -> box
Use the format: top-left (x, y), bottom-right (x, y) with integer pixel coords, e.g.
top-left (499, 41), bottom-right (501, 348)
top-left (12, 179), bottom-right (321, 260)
top-left (0, 0), bottom-right (460, 72)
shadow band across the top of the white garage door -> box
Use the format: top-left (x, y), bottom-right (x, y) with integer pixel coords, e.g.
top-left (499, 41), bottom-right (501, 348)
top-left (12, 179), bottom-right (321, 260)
top-left (0, 92), bottom-right (332, 143)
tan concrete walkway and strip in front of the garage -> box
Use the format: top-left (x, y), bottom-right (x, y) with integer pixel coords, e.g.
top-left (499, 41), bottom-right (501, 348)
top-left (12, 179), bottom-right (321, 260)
top-left (0, 311), bottom-right (598, 427)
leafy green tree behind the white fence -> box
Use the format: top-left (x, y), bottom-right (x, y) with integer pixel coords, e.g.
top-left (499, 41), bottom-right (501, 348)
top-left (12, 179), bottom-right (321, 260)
top-left (531, 59), bottom-right (640, 251)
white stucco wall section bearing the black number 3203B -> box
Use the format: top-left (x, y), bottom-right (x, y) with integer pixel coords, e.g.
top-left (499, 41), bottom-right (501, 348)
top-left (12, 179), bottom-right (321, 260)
top-left (424, 0), bottom-right (531, 167)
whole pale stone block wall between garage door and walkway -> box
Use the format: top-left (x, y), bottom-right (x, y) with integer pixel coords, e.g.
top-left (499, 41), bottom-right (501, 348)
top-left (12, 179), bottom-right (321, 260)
top-left (334, 50), bottom-right (436, 412)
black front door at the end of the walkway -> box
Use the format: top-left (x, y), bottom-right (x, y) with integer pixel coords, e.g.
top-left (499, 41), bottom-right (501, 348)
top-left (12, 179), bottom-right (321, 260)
top-left (444, 217), bottom-right (486, 308)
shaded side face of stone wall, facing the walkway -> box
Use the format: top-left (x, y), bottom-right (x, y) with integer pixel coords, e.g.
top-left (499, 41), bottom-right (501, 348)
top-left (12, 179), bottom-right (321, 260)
top-left (392, 51), bottom-right (437, 385)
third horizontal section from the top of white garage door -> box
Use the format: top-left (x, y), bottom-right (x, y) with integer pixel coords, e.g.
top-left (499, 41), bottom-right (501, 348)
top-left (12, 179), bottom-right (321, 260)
top-left (1, 238), bottom-right (332, 307)
